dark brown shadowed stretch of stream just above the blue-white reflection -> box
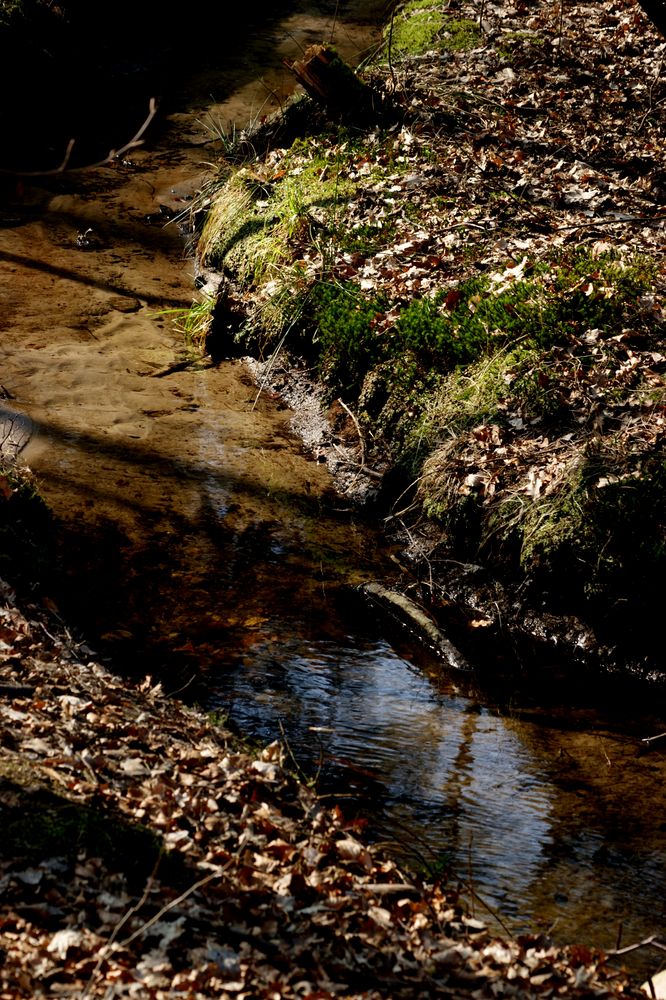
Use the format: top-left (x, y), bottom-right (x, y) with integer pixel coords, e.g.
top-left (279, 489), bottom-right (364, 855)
top-left (13, 402), bottom-right (377, 690)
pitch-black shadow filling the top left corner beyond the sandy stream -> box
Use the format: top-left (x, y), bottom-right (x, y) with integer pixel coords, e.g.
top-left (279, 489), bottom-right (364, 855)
top-left (0, 0), bottom-right (296, 170)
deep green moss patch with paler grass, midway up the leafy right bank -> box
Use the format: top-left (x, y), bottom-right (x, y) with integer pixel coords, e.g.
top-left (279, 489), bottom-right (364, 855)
top-left (292, 250), bottom-right (654, 426)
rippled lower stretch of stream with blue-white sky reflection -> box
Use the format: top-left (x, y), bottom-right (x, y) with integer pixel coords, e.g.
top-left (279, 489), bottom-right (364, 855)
top-left (212, 623), bottom-right (666, 971)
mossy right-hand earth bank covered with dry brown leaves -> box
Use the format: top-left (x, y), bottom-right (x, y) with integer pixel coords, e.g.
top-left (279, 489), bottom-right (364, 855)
top-left (192, 3), bottom-right (666, 682)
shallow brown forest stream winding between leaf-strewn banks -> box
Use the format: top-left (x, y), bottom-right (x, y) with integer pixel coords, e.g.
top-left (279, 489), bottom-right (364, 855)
top-left (0, 0), bottom-right (666, 970)
